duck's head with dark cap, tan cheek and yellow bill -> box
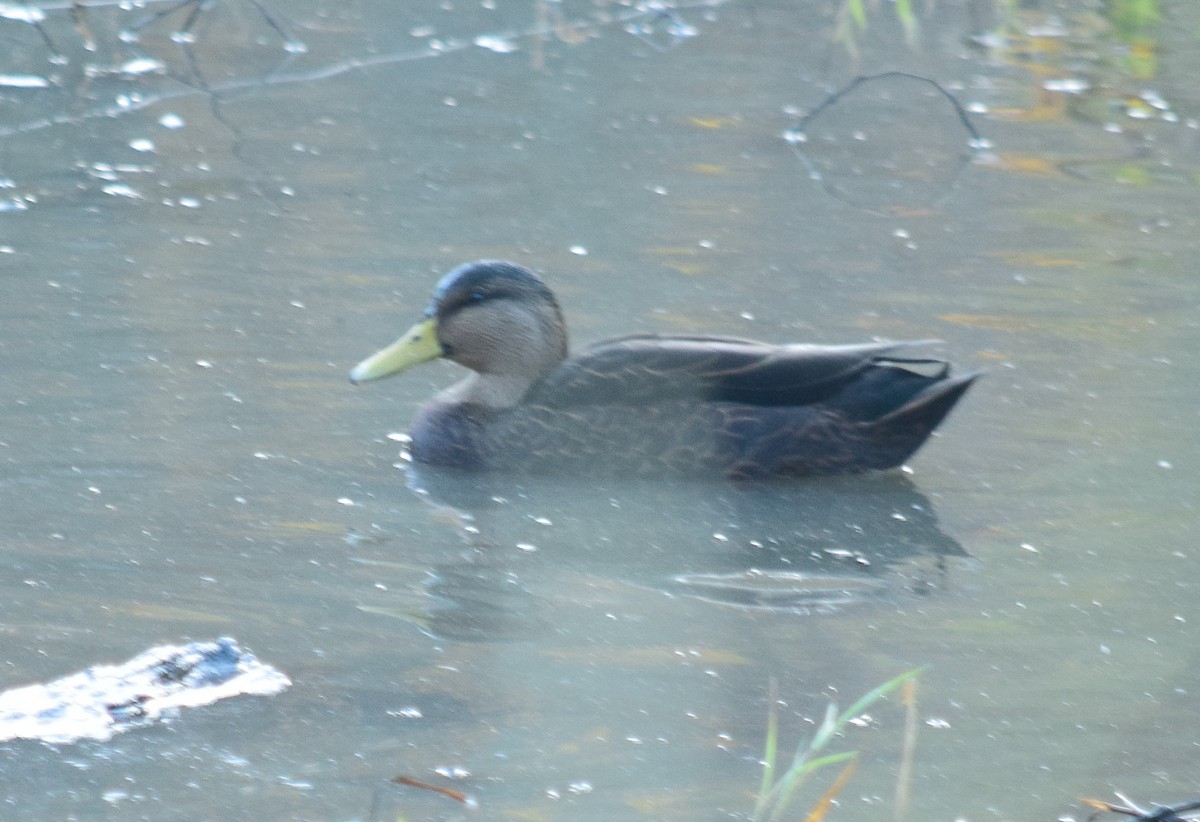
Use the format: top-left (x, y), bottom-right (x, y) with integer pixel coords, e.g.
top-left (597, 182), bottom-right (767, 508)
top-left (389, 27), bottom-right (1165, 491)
top-left (350, 260), bottom-right (566, 386)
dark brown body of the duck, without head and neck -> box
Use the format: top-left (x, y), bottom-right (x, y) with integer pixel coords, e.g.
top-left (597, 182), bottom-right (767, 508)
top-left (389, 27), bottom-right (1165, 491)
top-left (413, 336), bottom-right (973, 476)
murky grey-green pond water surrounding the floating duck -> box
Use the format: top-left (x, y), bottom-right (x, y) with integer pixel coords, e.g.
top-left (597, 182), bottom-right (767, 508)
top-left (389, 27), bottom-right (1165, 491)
top-left (0, 0), bottom-right (1200, 820)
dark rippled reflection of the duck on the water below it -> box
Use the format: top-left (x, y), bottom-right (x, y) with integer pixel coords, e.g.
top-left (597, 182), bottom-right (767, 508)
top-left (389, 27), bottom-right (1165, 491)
top-left (352, 466), bottom-right (967, 642)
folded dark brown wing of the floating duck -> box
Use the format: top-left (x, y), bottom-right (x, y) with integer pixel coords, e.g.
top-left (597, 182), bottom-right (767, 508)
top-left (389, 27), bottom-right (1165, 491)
top-left (526, 335), bottom-right (944, 407)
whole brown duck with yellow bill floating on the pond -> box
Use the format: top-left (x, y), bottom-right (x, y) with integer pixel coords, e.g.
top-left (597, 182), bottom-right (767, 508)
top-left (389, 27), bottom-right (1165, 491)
top-left (350, 260), bottom-right (978, 479)
